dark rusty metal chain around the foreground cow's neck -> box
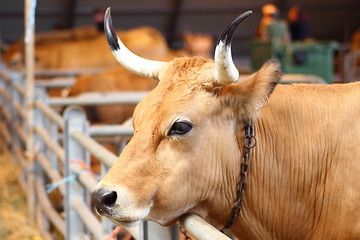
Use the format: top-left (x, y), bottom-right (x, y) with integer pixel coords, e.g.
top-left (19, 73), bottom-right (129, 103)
top-left (221, 120), bottom-right (256, 232)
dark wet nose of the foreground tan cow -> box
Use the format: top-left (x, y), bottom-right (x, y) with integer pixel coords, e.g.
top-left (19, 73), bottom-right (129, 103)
top-left (91, 189), bottom-right (117, 215)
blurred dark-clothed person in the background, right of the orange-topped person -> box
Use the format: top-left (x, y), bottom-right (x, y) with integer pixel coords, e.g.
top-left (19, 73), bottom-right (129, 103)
top-left (288, 6), bottom-right (309, 41)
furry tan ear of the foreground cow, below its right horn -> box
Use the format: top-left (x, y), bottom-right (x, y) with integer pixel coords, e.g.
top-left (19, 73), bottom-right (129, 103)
top-left (220, 59), bottom-right (282, 115)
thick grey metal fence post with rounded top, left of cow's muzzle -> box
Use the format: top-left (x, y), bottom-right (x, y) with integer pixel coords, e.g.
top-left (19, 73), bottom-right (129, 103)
top-left (64, 106), bottom-right (88, 240)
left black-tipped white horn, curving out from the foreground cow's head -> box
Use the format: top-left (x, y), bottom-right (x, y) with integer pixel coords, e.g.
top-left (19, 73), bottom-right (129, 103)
top-left (104, 7), bottom-right (166, 79)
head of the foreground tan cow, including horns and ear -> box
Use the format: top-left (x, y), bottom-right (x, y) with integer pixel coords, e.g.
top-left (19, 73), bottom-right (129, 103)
top-left (92, 7), bottom-right (281, 227)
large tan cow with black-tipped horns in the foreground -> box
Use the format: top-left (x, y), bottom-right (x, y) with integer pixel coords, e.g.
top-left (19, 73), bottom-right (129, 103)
top-left (92, 8), bottom-right (360, 239)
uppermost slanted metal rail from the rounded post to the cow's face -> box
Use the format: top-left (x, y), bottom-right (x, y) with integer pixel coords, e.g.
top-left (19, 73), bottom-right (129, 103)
top-left (71, 130), bottom-right (117, 167)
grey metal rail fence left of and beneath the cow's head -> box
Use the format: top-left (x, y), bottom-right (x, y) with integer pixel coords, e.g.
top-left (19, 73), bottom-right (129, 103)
top-left (0, 64), bottom-right (229, 239)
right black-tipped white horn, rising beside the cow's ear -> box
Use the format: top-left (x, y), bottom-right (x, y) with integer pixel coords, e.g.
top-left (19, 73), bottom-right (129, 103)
top-left (214, 11), bottom-right (252, 84)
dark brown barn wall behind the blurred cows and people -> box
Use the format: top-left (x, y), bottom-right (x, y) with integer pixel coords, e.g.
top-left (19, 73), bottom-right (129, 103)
top-left (0, 0), bottom-right (359, 82)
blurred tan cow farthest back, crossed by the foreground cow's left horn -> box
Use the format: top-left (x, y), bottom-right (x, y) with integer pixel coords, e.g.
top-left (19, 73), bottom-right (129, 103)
top-left (4, 26), bottom-right (169, 69)
